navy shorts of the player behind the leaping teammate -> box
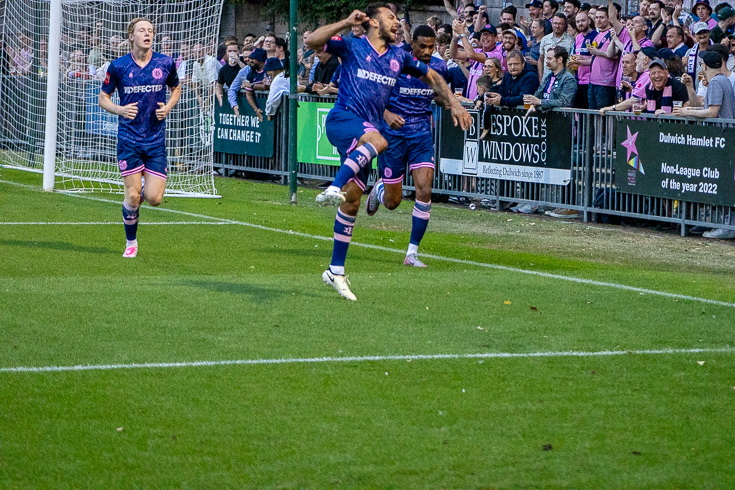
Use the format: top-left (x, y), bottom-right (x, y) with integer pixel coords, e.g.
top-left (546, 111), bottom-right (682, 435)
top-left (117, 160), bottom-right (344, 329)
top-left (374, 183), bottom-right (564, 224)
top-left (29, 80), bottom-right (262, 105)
top-left (378, 133), bottom-right (434, 184)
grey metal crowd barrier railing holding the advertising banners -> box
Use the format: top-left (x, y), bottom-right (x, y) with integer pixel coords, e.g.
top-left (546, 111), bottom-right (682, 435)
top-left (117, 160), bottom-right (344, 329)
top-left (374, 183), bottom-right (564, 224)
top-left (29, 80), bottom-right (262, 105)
top-left (177, 93), bottom-right (735, 235)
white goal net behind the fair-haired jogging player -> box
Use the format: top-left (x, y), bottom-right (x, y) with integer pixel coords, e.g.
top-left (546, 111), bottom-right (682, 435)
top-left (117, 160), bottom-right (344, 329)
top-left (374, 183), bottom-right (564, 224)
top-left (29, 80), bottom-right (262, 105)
top-left (0, 0), bottom-right (223, 197)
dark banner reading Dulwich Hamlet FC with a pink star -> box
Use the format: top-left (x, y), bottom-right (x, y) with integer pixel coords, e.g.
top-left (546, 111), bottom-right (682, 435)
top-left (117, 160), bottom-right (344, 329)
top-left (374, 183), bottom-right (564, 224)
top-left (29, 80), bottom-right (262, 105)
top-left (615, 120), bottom-right (735, 206)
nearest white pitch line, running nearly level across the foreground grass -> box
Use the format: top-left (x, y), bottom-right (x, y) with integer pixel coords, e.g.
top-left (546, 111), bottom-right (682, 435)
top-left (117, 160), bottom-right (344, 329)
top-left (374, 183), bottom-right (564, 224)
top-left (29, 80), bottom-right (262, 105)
top-left (0, 347), bottom-right (735, 373)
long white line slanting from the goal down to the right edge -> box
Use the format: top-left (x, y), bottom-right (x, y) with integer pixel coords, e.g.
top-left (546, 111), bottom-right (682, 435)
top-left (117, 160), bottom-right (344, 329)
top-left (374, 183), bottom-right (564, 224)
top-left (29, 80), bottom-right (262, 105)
top-left (0, 180), bottom-right (735, 308)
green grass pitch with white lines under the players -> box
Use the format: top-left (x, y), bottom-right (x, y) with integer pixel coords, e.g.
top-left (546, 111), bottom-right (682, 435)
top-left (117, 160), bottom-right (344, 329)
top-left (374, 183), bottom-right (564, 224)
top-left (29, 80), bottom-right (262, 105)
top-left (0, 168), bottom-right (735, 489)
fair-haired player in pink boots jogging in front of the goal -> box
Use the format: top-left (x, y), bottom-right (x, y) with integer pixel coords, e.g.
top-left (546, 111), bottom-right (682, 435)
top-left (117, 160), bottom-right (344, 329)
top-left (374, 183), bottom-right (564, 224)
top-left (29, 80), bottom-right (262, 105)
top-left (99, 17), bottom-right (181, 258)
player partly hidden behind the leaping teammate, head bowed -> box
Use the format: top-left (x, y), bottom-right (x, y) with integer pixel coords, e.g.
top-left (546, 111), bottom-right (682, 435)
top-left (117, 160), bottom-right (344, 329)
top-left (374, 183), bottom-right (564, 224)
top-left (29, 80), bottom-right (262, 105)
top-left (365, 25), bottom-right (447, 267)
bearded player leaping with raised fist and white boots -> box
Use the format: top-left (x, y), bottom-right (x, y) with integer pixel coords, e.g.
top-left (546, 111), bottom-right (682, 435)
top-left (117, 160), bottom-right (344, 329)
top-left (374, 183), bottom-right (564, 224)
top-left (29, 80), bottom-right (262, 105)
top-left (306, 4), bottom-right (472, 301)
